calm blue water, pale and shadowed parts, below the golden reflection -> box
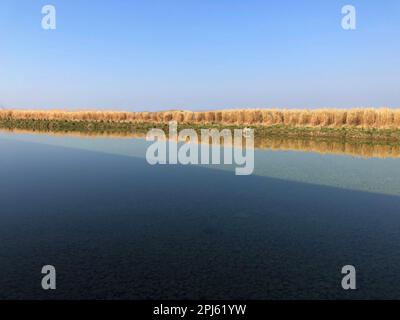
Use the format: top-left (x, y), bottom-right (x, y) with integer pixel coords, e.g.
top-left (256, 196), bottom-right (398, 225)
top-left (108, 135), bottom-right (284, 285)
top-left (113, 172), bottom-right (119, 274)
top-left (0, 133), bottom-right (400, 299)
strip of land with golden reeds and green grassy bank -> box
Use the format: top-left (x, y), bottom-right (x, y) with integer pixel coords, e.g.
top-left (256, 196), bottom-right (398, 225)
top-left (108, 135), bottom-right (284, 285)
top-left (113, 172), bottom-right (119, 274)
top-left (0, 108), bottom-right (400, 141)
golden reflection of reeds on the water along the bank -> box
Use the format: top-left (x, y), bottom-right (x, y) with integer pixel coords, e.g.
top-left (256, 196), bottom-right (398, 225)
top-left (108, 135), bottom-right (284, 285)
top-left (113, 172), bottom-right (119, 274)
top-left (0, 129), bottom-right (400, 158)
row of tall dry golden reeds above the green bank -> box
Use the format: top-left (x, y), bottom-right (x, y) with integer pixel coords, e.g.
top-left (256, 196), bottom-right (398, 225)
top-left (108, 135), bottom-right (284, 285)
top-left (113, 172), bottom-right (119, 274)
top-left (0, 108), bottom-right (400, 129)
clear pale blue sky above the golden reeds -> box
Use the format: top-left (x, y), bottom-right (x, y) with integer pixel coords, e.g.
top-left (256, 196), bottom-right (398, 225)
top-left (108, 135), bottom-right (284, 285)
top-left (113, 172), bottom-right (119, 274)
top-left (0, 0), bottom-right (400, 111)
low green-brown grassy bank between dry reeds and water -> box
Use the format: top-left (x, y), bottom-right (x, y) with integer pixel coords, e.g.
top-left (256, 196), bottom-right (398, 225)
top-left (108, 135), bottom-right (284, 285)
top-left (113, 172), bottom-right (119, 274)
top-left (0, 118), bottom-right (400, 143)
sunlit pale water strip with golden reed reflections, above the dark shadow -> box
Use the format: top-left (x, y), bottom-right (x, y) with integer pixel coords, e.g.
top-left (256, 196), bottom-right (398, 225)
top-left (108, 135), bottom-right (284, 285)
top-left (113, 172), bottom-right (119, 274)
top-left (0, 131), bottom-right (400, 196)
